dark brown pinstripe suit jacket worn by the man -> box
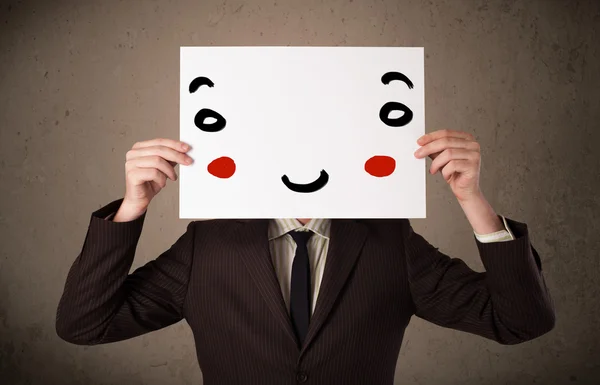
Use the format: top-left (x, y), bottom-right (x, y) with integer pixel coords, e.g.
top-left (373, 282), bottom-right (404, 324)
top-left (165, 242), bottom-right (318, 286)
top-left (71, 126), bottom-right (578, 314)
top-left (56, 200), bottom-right (554, 385)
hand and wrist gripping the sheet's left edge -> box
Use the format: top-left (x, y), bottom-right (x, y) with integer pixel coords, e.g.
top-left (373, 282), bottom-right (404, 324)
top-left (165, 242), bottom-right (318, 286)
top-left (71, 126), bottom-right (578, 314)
top-left (113, 138), bottom-right (193, 222)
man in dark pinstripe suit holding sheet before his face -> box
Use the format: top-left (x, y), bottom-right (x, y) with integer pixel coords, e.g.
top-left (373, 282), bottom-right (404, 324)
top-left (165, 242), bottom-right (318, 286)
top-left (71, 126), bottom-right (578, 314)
top-left (56, 130), bottom-right (555, 385)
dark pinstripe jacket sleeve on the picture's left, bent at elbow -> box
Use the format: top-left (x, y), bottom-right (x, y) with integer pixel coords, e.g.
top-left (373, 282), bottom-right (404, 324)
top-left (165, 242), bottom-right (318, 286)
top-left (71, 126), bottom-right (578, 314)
top-left (56, 199), bottom-right (194, 345)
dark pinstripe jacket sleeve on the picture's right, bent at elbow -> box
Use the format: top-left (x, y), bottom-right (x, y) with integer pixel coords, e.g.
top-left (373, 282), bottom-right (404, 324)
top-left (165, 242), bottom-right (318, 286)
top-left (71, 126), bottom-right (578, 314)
top-left (404, 214), bottom-right (555, 345)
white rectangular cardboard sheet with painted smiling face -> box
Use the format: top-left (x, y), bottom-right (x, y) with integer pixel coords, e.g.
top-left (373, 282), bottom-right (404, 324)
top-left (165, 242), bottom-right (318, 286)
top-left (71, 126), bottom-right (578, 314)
top-left (179, 47), bottom-right (426, 219)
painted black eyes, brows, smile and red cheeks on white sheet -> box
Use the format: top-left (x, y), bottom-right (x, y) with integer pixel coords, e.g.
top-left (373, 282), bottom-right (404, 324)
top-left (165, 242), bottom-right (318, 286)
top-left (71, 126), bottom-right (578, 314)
top-left (189, 71), bottom-right (414, 193)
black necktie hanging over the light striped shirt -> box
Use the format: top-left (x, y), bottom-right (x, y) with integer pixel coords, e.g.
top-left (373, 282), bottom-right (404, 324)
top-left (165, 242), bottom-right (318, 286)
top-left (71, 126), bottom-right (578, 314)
top-left (289, 231), bottom-right (313, 345)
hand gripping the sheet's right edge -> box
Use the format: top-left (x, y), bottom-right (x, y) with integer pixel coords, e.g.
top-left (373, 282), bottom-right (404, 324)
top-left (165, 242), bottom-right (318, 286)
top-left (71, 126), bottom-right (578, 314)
top-left (415, 130), bottom-right (481, 202)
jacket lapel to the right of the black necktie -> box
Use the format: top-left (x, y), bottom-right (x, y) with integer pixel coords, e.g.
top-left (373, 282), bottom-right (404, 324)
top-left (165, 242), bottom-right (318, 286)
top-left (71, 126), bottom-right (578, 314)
top-left (302, 219), bottom-right (368, 355)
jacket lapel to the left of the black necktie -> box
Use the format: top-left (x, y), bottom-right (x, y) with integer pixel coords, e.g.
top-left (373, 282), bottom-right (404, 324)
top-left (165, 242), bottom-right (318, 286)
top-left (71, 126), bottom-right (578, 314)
top-left (236, 220), bottom-right (298, 346)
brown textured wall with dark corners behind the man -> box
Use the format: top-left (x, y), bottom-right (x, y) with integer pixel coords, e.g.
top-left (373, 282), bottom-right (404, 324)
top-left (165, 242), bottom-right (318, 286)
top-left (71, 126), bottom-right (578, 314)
top-left (0, 0), bottom-right (600, 385)
